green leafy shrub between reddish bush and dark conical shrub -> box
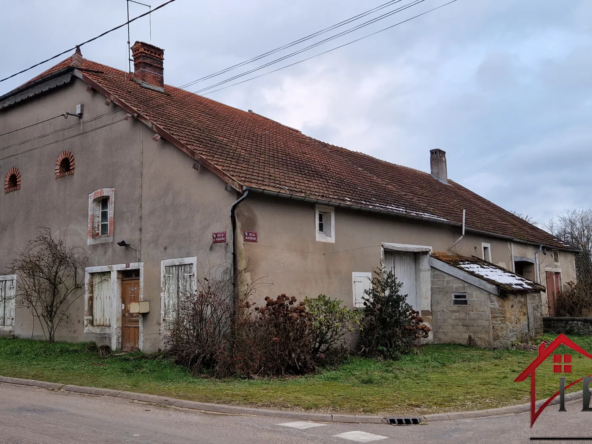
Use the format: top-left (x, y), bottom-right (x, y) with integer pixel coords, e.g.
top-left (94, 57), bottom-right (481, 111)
top-left (304, 294), bottom-right (362, 363)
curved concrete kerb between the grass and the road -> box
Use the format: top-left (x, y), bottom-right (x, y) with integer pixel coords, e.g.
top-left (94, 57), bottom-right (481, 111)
top-left (0, 376), bottom-right (583, 424)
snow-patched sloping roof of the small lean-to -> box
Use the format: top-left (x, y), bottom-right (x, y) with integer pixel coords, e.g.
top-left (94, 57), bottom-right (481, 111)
top-left (432, 253), bottom-right (545, 293)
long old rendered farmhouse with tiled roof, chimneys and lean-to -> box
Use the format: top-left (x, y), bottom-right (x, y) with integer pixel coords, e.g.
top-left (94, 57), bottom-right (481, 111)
top-left (0, 42), bottom-right (576, 351)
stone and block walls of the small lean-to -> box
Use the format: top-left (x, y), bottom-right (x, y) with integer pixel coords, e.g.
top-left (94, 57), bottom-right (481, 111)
top-left (432, 268), bottom-right (540, 348)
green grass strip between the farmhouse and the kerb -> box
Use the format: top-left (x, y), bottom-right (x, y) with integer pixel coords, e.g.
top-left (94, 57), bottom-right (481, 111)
top-left (0, 335), bottom-right (592, 415)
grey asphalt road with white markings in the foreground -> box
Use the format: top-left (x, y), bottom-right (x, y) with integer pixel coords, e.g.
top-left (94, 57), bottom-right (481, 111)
top-left (0, 383), bottom-right (592, 444)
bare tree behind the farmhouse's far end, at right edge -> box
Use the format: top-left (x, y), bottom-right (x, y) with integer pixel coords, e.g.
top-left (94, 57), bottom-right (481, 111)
top-left (546, 210), bottom-right (592, 282)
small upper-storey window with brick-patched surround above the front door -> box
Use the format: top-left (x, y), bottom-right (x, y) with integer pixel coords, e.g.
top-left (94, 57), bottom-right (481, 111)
top-left (88, 188), bottom-right (115, 245)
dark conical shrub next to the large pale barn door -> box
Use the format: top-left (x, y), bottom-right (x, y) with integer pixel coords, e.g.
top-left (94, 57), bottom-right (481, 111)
top-left (360, 266), bottom-right (430, 360)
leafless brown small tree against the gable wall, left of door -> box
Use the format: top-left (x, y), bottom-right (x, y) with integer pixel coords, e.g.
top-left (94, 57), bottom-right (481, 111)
top-left (10, 229), bottom-right (86, 342)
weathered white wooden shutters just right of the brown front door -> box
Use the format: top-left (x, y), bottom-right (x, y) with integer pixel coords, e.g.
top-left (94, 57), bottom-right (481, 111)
top-left (163, 264), bottom-right (195, 330)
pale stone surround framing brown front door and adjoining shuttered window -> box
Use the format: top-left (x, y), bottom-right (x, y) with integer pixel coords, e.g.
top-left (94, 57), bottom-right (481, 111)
top-left (83, 262), bottom-right (144, 350)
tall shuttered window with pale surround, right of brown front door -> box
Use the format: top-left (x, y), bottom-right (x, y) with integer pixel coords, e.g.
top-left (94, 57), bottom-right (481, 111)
top-left (161, 258), bottom-right (196, 332)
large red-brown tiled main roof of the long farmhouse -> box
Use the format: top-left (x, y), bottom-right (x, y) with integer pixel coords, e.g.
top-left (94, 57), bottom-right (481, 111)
top-left (6, 53), bottom-right (573, 249)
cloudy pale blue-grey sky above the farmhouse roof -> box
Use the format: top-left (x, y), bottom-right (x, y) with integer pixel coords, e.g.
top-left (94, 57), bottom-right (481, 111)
top-left (0, 0), bottom-right (592, 225)
